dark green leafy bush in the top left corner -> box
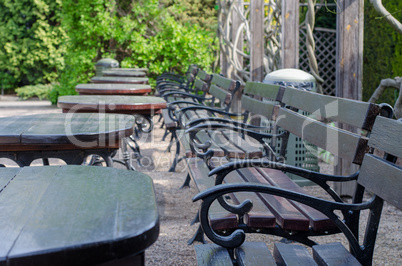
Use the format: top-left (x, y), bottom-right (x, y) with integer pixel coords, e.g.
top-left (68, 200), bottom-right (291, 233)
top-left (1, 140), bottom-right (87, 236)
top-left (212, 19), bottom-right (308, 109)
top-left (0, 0), bottom-right (65, 89)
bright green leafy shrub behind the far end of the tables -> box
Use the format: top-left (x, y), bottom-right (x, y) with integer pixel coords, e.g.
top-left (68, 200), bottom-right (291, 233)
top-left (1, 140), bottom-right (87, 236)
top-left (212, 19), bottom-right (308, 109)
top-left (51, 0), bottom-right (216, 102)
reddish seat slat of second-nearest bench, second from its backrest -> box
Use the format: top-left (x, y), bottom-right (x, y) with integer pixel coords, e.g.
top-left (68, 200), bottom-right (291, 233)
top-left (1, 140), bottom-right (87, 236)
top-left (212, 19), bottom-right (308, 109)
top-left (237, 168), bottom-right (309, 231)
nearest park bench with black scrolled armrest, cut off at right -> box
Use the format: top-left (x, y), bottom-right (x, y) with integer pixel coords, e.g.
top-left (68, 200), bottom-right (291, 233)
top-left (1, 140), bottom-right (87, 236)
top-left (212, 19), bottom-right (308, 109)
top-left (193, 116), bottom-right (402, 265)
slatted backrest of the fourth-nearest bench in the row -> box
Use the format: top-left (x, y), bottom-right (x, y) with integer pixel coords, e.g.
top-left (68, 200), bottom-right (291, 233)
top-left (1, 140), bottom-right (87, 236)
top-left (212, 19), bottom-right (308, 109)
top-left (208, 74), bottom-right (240, 111)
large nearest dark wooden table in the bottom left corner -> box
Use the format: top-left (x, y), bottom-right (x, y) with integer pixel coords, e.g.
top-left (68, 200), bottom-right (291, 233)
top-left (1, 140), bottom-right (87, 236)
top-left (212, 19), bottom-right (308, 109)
top-left (0, 165), bottom-right (159, 266)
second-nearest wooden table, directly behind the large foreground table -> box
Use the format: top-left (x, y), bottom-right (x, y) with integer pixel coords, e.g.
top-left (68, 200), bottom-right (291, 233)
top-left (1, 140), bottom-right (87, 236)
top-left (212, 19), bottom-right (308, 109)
top-left (0, 113), bottom-right (135, 167)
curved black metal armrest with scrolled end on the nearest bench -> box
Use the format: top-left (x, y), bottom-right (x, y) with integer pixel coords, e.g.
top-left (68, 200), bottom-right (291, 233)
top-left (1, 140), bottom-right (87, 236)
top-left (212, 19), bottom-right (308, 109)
top-left (193, 183), bottom-right (376, 251)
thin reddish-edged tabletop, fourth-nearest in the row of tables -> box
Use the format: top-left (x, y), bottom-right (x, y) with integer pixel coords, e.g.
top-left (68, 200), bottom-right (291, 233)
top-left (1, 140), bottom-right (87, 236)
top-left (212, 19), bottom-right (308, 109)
top-left (75, 83), bottom-right (152, 95)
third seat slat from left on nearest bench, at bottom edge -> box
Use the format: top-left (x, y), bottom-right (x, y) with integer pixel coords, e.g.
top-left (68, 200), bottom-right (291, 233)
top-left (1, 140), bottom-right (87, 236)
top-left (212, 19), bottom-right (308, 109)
top-left (274, 243), bottom-right (317, 266)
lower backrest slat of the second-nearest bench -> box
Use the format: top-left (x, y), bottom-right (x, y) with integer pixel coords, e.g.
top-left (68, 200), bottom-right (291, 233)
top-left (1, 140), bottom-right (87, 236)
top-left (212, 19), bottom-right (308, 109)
top-left (276, 107), bottom-right (367, 164)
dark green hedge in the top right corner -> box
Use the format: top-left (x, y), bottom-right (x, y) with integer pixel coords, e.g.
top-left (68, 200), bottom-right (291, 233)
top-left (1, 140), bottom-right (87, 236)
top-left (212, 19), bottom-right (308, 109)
top-left (363, 0), bottom-right (402, 105)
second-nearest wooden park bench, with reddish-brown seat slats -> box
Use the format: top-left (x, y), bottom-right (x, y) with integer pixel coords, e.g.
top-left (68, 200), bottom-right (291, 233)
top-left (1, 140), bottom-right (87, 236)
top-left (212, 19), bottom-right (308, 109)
top-left (180, 82), bottom-right (392, 246)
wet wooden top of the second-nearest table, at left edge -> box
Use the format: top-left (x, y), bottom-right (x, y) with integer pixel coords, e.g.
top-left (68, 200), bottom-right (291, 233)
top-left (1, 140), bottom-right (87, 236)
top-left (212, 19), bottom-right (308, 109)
top-left (0, 113), bottom-right (134, 148)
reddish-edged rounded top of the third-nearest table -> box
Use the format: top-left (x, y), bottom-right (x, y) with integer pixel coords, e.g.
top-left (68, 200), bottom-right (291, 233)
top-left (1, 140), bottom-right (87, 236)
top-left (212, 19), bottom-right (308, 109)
top-left (57, 95), bottom-right (166, 114)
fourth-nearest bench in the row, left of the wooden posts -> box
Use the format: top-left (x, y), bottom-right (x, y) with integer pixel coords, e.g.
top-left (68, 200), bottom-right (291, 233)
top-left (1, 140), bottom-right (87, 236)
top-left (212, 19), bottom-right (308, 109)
top-left (162, 74), bottom-right (240, 172)
